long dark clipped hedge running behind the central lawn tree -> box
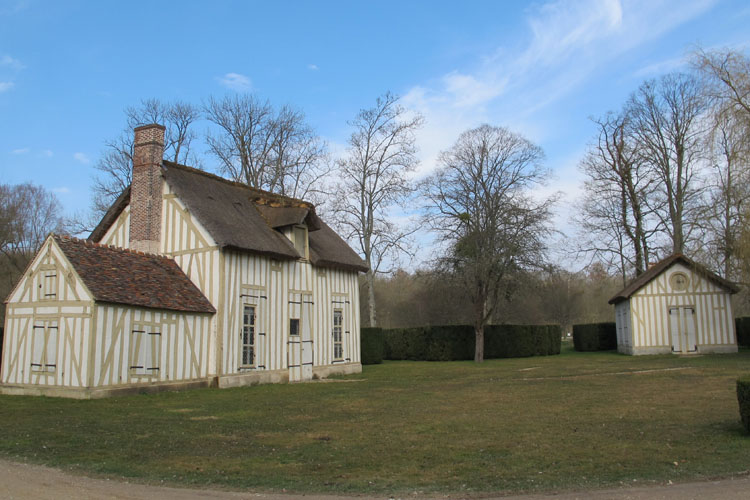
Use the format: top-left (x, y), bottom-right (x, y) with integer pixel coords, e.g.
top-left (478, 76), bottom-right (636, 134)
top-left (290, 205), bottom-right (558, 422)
top-left (361, 325), bottom-right (561, 364)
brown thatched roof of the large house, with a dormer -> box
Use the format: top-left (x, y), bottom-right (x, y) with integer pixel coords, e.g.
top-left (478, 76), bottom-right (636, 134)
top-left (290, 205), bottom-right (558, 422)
top-left (89, 161), bottom-right (367, 272)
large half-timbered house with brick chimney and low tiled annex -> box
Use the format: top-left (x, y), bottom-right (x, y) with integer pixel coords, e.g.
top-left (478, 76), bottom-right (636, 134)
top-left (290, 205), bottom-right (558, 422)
top-left (1, 125), bottom-right (366, 397)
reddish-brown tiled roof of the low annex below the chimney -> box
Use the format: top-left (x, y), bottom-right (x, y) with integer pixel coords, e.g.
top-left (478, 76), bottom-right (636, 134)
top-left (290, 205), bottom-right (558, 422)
top-left (52, 235), bottom-right (216, 313)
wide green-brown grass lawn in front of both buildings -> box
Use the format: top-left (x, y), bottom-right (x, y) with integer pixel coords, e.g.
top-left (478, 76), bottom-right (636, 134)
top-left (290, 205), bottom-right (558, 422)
top-left (0, 347), bottom-right (750, 494)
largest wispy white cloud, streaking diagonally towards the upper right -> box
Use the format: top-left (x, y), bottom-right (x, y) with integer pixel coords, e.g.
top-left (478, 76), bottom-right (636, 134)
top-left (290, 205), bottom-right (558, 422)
top-left (403, 0), bottom-right (715, 180)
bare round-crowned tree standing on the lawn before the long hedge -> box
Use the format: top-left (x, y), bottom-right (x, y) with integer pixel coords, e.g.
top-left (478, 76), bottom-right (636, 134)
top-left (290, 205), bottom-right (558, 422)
top-left (425, 125), bottom-right (554, 362)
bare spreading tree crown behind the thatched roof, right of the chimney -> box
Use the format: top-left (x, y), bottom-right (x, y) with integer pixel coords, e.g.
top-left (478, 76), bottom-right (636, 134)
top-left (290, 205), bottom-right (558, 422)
top-left (204, 94), bottom-right (330, 202)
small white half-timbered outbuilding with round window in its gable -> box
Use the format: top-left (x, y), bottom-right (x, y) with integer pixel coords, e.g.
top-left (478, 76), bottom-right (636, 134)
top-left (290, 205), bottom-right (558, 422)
top-left (609, 254), bottom-right (737, 354)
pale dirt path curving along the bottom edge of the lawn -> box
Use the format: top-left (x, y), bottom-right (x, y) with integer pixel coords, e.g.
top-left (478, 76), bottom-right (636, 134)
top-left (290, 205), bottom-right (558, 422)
top-left (0, 460), bottom-right (750, 500)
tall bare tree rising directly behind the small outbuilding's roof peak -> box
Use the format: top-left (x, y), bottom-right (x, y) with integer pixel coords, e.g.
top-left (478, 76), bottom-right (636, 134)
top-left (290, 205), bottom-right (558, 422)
top-left (628, 73), bottom-right (708, 253)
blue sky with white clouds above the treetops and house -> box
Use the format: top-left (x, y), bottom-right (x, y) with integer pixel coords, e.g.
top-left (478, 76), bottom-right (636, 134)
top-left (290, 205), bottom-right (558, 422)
top-left (0, 0), bottom-right (750, 266)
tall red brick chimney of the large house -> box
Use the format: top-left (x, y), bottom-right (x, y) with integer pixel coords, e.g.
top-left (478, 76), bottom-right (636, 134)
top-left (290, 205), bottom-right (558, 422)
top-left (130, 124), bottom-right (165, 253)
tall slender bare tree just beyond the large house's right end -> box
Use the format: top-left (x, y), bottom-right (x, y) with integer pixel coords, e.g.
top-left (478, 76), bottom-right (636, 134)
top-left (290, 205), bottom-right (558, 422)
top-left (333, 92), bottom-right (424, 326)
